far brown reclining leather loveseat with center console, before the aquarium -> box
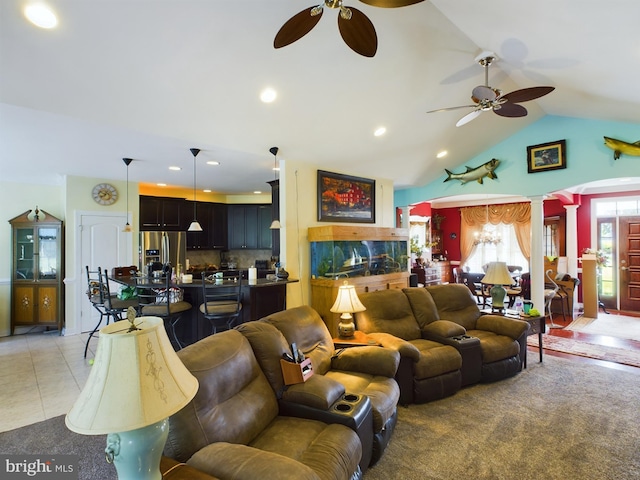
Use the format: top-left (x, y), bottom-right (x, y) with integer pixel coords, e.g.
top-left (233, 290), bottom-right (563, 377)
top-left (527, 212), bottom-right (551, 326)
top-left (355, 284), bottom-right (529, 404)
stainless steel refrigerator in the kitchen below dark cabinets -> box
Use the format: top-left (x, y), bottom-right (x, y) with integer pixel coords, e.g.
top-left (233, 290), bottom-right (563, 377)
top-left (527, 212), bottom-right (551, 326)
top-left (139, 232), bottom-right (187, 272)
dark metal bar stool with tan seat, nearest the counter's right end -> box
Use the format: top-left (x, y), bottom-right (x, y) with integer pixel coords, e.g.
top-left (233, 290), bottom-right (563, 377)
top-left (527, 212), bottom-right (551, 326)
top-left (200, 272), bottom-right (242, 335)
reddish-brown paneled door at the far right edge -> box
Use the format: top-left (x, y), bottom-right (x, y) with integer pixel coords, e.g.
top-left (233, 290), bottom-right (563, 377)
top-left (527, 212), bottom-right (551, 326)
top-left (619, 217), bottom-right (640, 312)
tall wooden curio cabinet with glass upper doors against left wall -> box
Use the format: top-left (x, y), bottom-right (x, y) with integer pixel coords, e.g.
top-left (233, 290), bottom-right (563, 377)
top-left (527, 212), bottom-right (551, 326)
top-left (9, 207), bottom-right (64, 335)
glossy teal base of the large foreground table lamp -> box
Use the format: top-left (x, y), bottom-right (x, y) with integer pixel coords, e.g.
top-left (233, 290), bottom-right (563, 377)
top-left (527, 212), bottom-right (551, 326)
top-left (104, 418), bottom-right (169, 480)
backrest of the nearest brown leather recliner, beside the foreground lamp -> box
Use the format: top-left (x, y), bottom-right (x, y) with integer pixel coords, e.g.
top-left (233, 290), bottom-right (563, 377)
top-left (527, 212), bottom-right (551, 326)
top-left (165, 330), bottom-right (278, 462)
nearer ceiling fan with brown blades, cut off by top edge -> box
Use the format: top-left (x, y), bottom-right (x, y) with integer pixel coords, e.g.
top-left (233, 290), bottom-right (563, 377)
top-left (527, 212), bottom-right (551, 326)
top-left (273, 0), bottom-right (424, 57)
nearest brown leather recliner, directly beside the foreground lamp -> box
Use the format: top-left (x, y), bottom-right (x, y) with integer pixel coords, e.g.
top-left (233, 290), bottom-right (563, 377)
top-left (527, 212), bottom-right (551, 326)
top-left (164, 330), bottom-right (362, 480)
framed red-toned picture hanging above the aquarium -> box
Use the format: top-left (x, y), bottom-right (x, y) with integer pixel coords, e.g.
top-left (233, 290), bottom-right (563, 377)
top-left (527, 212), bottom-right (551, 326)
top-left (318, 170), bottom-right (376, 223)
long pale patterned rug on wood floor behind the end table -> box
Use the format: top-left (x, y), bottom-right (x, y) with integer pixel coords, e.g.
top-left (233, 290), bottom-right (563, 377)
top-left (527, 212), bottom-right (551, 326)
top-left (527, 335), bottom-right (640, 367)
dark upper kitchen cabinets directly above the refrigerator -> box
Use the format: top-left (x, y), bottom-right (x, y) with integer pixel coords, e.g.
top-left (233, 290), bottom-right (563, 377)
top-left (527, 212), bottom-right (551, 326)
top-left (140, 195), bottom-right (185, 231)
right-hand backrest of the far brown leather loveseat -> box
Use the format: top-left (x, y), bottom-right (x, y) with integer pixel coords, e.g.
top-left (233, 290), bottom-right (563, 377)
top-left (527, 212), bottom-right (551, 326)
top-left (426, 283), bottom-right (480, 330)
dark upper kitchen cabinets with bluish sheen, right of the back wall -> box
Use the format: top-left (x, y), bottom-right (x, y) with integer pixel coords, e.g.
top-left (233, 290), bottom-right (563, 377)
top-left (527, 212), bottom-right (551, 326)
top-left (227, 204), bottom-right (271, 250)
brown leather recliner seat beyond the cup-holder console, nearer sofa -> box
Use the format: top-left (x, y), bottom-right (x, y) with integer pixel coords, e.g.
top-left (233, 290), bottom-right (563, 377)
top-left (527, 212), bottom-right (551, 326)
top-left (236, 305), bottom-right (400, 465)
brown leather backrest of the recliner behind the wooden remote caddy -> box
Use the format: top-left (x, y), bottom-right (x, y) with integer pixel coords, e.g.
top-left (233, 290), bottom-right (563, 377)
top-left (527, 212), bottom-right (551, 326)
top-left (262, 305), bottom-right (335, 375)
